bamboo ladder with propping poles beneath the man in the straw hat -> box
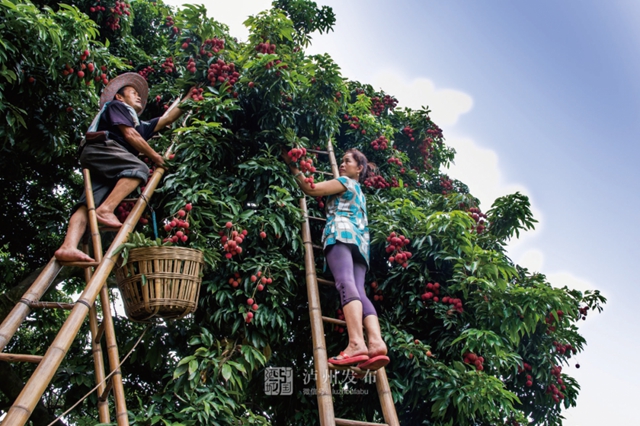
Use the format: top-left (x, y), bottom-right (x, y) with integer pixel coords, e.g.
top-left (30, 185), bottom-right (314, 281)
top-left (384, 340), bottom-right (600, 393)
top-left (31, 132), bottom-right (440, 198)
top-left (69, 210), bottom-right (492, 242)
top-left (0, 139), bottom-right (172, 426)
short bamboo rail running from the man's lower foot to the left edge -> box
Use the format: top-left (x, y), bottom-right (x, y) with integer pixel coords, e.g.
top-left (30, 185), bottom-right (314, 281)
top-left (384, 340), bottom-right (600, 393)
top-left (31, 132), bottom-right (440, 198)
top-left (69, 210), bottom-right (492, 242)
top-left (0, 257), bottom-right (62, 351)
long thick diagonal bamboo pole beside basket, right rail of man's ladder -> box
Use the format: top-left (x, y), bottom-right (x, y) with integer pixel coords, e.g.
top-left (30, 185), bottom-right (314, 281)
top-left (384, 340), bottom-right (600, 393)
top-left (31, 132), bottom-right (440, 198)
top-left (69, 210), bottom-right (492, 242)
top-left (2, 163), bottom-right (170, 426)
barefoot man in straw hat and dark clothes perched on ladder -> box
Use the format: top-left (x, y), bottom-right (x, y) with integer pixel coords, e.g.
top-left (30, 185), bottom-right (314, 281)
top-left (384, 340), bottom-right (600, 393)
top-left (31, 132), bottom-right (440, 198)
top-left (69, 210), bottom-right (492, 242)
top-left (55, 72), bottom-right (182, 262)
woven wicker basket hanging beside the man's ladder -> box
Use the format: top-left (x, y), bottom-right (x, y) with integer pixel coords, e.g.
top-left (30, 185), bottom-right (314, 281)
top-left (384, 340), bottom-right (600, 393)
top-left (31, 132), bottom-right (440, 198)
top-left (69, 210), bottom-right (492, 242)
top-left (116, 246), bottom-right (204, 322)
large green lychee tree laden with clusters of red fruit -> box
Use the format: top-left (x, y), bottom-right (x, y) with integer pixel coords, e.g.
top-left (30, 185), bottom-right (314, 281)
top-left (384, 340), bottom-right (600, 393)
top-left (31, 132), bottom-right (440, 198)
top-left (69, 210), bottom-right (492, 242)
top-left (0, 0), bottom-right (605, 425)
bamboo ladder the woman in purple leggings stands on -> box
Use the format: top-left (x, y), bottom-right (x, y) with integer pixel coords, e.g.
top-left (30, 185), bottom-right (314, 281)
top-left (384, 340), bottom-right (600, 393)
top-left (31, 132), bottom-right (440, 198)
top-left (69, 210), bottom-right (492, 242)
top-left (300, 140), bottom-right (400, 426)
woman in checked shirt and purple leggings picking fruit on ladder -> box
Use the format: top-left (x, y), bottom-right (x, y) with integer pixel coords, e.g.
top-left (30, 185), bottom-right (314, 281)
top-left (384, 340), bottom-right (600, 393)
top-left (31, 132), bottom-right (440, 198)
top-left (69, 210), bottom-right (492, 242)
top-left (282, 149), bottom-right (389, 370)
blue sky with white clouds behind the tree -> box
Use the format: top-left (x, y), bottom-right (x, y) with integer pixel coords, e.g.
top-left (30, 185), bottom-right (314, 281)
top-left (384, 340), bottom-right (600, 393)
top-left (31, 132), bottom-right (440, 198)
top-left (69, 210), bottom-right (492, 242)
top-left (169, 0), bottom-right (640, 426)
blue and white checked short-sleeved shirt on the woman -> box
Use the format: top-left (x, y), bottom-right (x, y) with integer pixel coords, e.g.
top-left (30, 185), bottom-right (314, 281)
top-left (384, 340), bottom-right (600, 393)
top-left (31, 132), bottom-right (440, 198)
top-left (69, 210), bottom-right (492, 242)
top-left (322, 176), bottom-right (369, 266)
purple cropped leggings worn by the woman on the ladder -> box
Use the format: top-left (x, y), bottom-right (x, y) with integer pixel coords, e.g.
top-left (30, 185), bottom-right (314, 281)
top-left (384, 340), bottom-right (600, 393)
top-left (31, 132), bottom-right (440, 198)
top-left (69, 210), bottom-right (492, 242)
top-left (325, 242), bottom-right (377, 318)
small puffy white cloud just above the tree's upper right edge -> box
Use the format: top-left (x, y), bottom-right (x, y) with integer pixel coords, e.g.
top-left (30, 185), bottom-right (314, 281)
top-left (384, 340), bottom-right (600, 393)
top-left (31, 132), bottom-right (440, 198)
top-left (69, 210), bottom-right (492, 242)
top-left (372, 69), bottom-right (473, 127)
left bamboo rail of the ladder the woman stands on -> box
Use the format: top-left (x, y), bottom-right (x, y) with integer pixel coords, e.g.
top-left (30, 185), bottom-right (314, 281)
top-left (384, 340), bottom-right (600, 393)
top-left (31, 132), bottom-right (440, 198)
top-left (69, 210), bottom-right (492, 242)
top-left (300, 198), bottom-right (335, 426)
